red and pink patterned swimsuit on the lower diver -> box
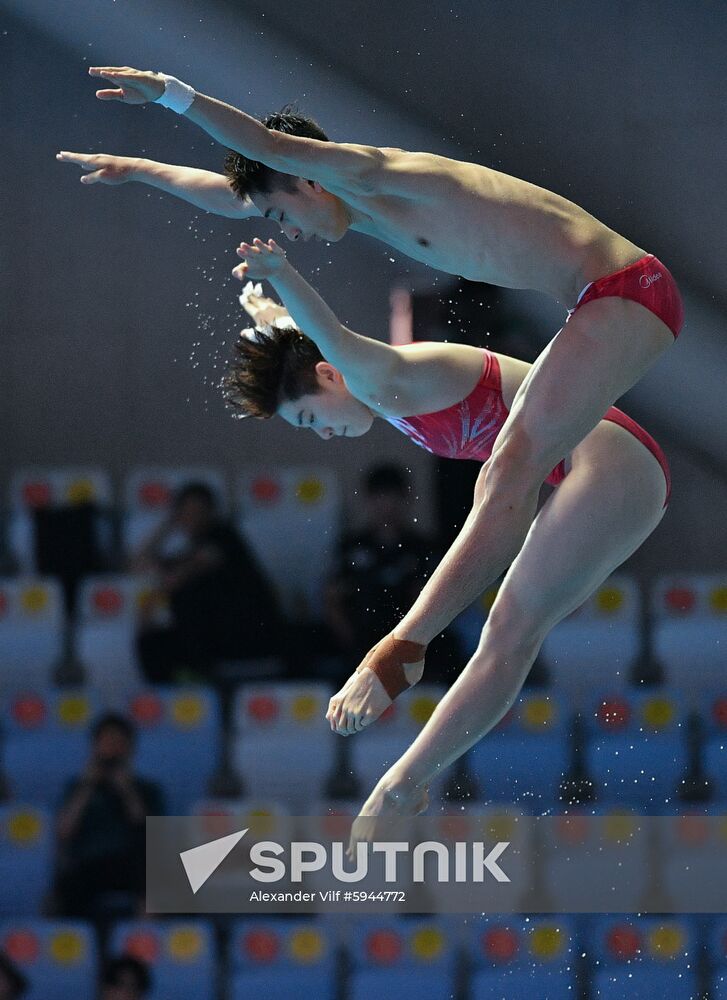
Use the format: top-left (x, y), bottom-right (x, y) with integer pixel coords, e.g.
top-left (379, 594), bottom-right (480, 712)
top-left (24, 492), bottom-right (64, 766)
top-left (386, 349), bottom-right (671, 506)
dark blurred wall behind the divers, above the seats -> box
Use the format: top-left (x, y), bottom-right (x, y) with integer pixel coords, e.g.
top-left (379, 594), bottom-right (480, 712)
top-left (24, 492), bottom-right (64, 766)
top-left (0, 0), bottom-right (727, 568)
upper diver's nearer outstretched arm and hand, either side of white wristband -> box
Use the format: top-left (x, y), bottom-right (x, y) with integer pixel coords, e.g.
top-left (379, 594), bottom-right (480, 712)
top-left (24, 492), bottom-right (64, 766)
top-left (88, 66), bottom-right (385, 195)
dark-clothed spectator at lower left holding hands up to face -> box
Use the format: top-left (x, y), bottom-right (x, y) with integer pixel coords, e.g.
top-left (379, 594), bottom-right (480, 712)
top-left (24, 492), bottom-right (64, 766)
top-left (56, 713), bottom-right (163, 919)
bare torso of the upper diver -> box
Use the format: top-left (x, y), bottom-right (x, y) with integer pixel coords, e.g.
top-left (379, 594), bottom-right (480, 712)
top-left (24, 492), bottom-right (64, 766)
top-left (329, 149), bottom-right (644, 307)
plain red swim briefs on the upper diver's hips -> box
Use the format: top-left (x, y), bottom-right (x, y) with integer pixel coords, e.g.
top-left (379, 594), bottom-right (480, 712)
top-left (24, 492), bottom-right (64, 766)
top-left (569, 253), bottom-right (684, 340)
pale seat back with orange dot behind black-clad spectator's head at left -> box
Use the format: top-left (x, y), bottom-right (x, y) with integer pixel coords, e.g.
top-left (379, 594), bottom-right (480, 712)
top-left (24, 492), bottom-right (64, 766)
top-left (121, 466), bottom-right (228, 557)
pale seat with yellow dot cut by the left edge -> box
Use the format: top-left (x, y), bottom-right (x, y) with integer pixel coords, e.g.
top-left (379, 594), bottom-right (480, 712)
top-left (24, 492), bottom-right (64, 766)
top-left (0, 577), bottom-right (66, 694)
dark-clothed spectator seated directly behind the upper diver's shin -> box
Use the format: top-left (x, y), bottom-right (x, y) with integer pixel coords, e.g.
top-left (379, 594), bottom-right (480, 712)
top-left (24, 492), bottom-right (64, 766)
top-left (326, 464), bottom-right (463, 682)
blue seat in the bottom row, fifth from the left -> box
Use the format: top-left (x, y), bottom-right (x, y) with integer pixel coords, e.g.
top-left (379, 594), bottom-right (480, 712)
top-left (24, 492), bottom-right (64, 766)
top-left (466, 917), bottom-right (577, 1000)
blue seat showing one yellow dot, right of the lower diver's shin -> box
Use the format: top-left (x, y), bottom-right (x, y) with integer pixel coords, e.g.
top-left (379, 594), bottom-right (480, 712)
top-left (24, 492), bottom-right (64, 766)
top-left (466, 691), bottom-right (571, 812)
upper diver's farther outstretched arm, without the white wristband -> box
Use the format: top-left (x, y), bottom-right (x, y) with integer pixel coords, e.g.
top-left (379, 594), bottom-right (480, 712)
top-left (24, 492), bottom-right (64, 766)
top-left (56, 151), bottom-right (260, 219)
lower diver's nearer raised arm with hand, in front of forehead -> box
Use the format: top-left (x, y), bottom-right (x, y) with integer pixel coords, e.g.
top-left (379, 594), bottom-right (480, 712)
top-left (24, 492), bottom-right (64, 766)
top-left (232, 239), bottom-right (404, 398)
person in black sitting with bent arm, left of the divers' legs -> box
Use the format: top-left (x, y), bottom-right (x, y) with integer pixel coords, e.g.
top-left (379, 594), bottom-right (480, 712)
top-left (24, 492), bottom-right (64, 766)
top-left (132, 483), bottom-right (279, 684)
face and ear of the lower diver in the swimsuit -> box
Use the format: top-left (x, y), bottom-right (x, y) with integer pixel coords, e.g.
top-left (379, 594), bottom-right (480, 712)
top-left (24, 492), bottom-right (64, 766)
top-left (278, 361), bottom-right (374, 441)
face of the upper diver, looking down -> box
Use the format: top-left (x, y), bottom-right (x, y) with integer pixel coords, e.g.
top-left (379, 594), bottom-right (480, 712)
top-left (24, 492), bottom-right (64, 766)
top-left (252, 177), bottom-right (349, 243)
